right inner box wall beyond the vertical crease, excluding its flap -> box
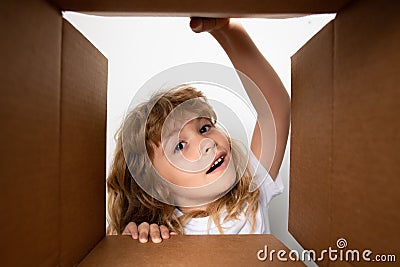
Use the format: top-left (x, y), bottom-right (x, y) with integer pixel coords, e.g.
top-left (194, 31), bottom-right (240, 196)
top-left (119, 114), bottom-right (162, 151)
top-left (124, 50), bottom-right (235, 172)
top-left (330, 0), bottom-right (400, 257)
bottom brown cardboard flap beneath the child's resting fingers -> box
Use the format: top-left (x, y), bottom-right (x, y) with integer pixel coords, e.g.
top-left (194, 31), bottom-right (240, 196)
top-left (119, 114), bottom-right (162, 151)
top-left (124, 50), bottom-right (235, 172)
top-left (79, 235), bottom-right (304, 267)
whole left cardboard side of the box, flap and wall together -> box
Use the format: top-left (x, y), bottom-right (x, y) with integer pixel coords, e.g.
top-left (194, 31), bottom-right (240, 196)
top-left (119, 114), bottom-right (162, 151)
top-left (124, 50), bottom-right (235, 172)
top-left (0, 1), bottom-right (107, 266)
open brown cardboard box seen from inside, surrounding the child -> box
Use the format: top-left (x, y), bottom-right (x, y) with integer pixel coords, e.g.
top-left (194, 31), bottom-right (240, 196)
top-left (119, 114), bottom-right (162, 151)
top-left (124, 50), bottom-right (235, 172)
top-left (0, 0), bottom-right (400, 266)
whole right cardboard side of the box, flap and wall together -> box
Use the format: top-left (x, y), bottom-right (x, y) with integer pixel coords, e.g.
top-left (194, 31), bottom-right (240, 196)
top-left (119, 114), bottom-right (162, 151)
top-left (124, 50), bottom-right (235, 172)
top-left (289, 0), bottom-right (400, 266)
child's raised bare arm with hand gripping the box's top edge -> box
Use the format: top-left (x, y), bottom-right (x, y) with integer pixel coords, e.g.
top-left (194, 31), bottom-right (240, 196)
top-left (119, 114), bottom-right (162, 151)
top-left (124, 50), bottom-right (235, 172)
top-left (190, 18), bottom-right (290, 179)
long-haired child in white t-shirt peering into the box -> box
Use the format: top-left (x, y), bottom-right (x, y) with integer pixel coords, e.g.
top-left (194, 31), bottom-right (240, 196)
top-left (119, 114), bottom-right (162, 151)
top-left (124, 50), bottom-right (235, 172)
top-left (107, 18), bottom-right (290, 243)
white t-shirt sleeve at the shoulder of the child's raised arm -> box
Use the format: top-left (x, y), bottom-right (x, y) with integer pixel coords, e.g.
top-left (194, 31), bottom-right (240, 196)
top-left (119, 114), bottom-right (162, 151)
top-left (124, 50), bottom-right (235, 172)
top-left (249, 151), bottom-right (284, 205)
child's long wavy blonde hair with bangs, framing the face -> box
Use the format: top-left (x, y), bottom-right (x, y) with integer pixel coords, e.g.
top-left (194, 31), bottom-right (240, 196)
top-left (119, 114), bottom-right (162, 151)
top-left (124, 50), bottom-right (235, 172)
top-left (107, 85), bottom-right (260, 234)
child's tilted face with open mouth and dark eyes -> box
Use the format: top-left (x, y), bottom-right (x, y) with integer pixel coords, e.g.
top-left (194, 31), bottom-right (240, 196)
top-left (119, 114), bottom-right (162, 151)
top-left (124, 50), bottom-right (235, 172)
top-left (153, 118), bottom-right (236, 191)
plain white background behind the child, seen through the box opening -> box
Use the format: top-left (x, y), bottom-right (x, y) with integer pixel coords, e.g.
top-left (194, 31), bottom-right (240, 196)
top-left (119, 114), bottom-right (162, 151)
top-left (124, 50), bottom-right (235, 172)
top-left (64, 12), bottom-right (335, 266)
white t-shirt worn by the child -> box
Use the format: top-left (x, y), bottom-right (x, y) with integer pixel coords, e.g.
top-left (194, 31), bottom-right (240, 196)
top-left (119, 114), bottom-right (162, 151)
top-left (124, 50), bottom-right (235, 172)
top-left (175, 153), bottom-right (284, 235)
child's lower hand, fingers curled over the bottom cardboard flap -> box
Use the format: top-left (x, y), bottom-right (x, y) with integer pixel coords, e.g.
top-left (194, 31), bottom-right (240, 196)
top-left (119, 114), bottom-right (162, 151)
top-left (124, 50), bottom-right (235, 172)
top-left (122, 222), bottom-right (176, 243)
